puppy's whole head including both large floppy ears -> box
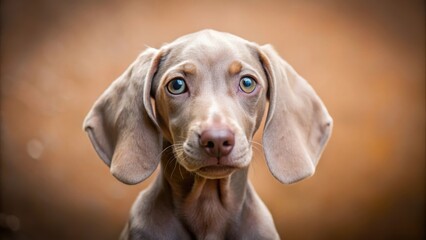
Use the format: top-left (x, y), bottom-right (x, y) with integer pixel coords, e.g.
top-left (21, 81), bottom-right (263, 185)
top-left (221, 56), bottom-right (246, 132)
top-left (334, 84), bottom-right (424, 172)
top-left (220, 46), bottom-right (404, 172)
top-left (84, 30), bottom-right (333, 184)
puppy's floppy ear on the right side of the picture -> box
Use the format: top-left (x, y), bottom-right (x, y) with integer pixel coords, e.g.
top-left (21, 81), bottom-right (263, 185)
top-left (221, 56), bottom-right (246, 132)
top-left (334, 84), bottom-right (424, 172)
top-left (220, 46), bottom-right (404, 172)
top-left (260, 45), bottom-right (333, 183)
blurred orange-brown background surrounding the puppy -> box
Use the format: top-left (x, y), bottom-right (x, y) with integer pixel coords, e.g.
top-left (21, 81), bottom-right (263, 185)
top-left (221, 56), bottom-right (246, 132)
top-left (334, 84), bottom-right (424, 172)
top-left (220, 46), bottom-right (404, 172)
top-left (0, 0), bottom-right (425, 239)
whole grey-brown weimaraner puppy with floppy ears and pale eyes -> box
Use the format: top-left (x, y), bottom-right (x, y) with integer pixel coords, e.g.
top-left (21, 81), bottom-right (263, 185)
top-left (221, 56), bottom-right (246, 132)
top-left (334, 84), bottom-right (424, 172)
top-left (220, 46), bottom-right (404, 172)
top-left (84, 30), bottom-right (332, 239)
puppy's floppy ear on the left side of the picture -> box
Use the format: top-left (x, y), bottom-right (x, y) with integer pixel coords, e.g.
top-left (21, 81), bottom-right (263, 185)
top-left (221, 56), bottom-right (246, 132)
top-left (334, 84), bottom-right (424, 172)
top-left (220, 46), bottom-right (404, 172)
top-left (83, 48), bottom-right (162, 184)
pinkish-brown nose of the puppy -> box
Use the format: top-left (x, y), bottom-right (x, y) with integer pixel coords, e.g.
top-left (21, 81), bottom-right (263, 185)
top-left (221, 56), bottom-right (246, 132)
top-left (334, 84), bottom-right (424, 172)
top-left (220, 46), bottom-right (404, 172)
top-left (200, 128), bottom-right (235, 158)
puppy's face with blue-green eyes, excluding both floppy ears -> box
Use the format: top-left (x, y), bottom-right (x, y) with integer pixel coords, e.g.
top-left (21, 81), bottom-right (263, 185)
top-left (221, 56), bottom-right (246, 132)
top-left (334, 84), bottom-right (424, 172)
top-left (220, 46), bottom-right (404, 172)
top-left (152, 32), bottom-right (268, 178)
